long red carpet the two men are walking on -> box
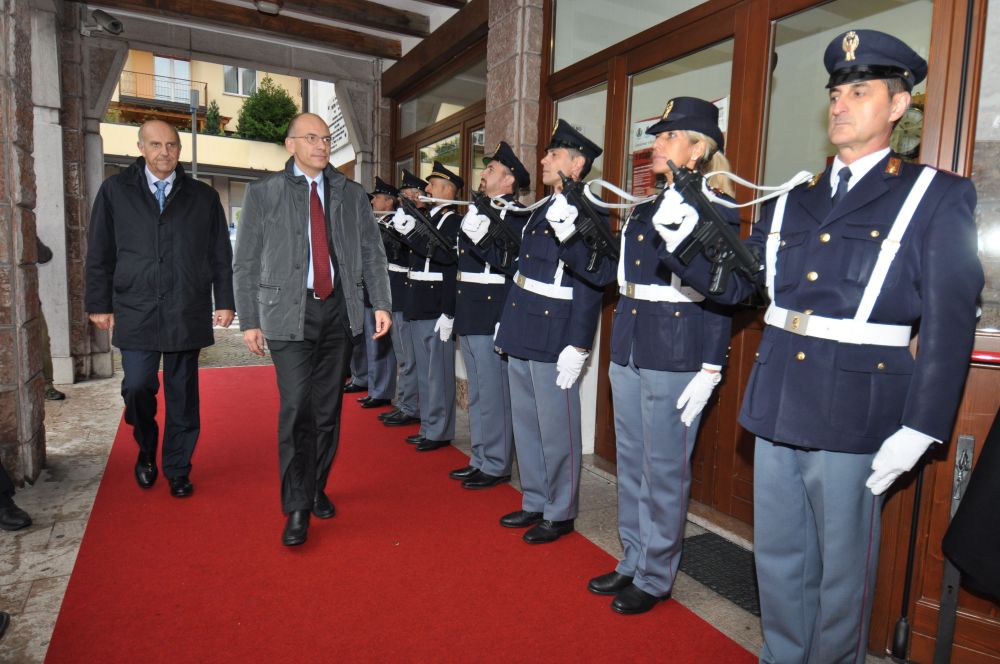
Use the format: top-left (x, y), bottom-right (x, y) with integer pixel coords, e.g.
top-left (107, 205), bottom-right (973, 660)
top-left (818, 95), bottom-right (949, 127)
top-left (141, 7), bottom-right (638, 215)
top-left (47, 367), bottom-right (755, 663)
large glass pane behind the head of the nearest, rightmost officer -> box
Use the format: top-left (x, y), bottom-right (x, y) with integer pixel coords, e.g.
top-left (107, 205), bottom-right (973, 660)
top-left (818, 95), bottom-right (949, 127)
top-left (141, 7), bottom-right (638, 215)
top-left (764, 0), bottom-right (934, 184)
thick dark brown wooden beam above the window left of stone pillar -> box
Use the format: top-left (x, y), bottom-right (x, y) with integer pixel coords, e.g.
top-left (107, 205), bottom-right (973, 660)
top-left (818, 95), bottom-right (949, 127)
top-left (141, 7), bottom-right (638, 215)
top-left (382, 0), bottom-right (490, 97)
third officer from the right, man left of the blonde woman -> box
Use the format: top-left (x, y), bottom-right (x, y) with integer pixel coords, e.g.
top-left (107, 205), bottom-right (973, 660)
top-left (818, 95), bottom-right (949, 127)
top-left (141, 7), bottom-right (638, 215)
top-left (487, 120), bottom-right (607, 544)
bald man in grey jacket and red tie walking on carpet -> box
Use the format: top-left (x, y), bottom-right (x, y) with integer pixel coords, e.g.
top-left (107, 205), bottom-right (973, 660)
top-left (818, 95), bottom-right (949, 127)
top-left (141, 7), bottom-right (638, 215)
top-left (233, 113), bottom-right (392, 546)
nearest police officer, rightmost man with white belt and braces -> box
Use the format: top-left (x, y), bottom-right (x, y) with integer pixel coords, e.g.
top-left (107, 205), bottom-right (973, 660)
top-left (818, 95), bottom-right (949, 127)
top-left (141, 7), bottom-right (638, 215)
top-left (657, 30), bottom-right (983, 664)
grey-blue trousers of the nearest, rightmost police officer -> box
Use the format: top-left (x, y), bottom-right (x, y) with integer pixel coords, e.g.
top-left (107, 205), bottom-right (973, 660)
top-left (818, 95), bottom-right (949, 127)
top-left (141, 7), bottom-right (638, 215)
top-left (754, 437), bottom-right (882, 664)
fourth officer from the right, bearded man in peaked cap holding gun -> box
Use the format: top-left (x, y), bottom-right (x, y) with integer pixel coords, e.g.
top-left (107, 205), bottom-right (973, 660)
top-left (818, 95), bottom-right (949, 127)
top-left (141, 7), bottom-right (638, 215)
top-left (449, 141), bottom-right (531, 489)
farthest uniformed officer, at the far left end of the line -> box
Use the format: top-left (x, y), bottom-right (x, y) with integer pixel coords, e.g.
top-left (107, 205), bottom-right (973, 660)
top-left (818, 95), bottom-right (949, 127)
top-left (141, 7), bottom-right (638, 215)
top-left (358, 177), bottom-right (403, 408)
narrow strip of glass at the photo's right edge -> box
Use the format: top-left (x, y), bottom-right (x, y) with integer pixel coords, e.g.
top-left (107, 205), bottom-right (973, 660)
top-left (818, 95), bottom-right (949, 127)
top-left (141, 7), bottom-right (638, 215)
top-left (972, 3), bottom-right (1000, 333)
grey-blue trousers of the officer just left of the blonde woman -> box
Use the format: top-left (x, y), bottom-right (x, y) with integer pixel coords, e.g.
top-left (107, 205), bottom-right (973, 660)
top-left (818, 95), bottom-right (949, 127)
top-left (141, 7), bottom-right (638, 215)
top-left (507, 357), bottom-right (583, 521)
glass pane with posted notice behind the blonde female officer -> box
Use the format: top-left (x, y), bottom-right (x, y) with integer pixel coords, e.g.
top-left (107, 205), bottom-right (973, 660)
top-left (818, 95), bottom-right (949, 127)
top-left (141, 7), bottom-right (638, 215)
top-left (624, 39), bottom-right (733, 196)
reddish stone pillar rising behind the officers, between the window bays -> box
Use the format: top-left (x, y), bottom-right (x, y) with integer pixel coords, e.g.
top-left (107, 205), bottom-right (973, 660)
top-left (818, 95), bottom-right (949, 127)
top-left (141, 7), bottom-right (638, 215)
top-left (486, 0), bottom-right (544, 200)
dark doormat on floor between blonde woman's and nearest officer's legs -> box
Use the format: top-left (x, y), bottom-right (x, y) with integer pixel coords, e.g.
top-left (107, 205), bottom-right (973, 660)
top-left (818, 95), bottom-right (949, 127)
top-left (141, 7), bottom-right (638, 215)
top-left (681, 533), bottom-right (760, 616)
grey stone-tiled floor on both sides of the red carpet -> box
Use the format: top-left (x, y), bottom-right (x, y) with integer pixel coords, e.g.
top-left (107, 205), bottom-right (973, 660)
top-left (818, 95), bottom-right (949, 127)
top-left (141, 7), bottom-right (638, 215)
top-left (0, 330), bottom-right (882, 664)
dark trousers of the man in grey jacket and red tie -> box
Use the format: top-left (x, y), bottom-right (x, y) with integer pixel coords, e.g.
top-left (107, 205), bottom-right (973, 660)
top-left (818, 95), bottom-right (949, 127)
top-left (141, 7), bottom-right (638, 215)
top-left (267, 289), bottom-right (363, 513)
